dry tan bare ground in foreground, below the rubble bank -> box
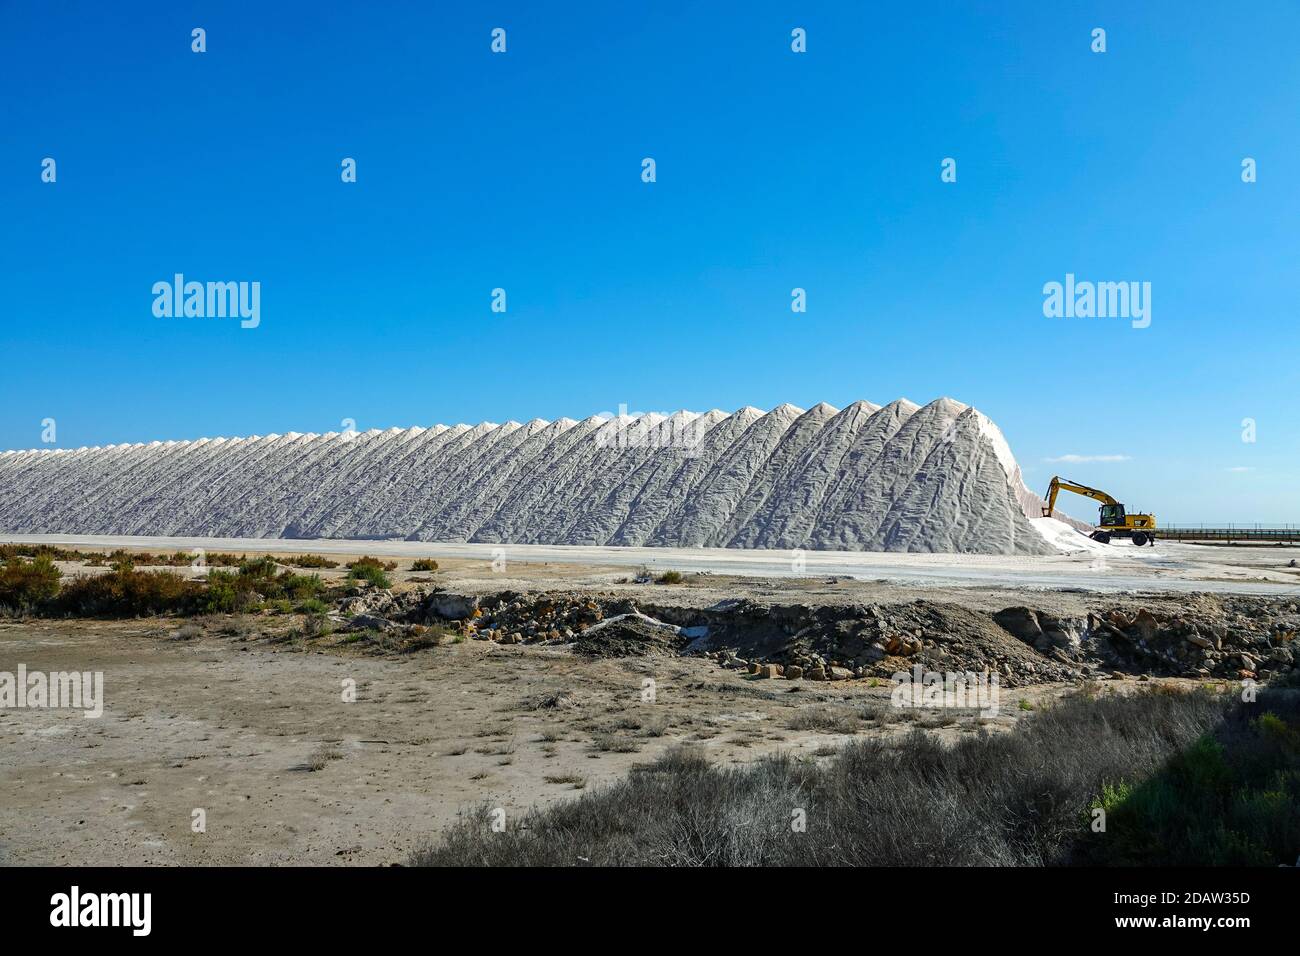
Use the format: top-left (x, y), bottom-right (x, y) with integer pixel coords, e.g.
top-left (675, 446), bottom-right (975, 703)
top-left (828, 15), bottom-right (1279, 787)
top-left (0, 618), bottom-right (1063, 865)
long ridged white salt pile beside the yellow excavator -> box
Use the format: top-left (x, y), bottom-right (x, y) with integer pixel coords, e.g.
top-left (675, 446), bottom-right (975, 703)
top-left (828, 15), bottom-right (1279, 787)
top-left (0, 398), bottom-right (1076, 554)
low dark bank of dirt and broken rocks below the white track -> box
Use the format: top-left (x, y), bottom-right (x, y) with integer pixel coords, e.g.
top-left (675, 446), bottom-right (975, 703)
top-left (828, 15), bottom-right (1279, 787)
top-left (419, 582), bottom-right (1300, 687)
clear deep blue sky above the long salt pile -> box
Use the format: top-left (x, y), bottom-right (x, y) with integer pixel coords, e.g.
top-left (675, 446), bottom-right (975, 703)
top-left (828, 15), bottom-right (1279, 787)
top-left (0, 0), bottom-right (1300, 522)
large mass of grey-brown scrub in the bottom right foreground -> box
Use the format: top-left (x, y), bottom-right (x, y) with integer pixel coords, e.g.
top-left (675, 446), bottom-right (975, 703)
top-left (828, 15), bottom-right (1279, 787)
top-left (412, 691), bottom-right (1300, 866)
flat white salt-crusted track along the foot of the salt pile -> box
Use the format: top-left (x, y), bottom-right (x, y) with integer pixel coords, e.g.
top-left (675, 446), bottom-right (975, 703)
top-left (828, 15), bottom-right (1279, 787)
top-left (0, 535), bottom-right (1300, 594)
